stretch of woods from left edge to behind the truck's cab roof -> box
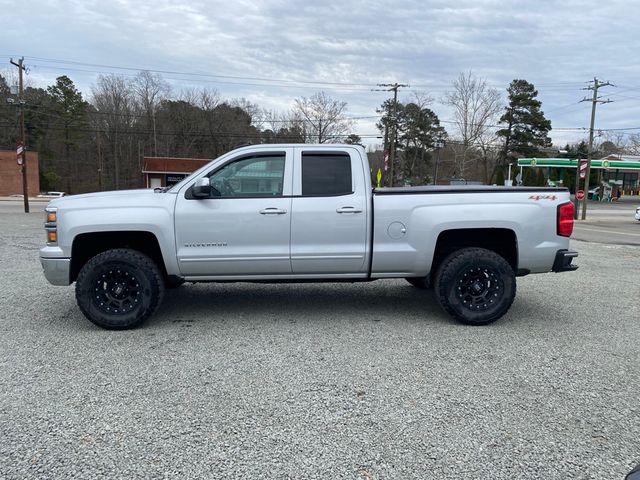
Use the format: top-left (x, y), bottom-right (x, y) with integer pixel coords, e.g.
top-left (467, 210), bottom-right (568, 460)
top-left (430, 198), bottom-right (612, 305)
top-left (0, 71), bottom-right (360, 193)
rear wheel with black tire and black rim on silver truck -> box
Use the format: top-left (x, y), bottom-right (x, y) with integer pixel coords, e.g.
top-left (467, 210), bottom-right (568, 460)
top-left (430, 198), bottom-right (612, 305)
top-left (434, 248), bottom-right (516, 325)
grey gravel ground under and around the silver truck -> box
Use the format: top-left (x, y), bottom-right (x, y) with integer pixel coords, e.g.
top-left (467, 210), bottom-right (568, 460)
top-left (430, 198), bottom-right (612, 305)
top-left (0, 205), bottom-right (640, 480)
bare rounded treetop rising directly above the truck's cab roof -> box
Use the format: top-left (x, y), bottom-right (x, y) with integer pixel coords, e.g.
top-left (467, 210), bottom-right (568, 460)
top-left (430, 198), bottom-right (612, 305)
top-left (294, 92), bottom-right (354, 143)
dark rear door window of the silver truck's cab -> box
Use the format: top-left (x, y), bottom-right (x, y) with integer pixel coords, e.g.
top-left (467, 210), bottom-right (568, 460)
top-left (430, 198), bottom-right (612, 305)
top-left (302, 153), bottom-right (353, 196)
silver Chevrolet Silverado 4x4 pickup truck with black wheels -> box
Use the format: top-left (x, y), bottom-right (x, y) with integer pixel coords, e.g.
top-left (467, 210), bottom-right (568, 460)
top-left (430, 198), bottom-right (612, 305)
top-left (40, 144), bottom-right (577, 329)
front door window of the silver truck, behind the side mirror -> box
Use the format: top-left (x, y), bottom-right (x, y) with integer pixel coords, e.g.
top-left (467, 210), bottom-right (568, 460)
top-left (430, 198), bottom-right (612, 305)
top-left (210, 154), bottom-right (285, 197)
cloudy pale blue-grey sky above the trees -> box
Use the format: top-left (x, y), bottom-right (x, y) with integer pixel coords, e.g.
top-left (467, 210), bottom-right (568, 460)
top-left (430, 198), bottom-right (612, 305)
top-left (0, 0), bottom-right (640, 147)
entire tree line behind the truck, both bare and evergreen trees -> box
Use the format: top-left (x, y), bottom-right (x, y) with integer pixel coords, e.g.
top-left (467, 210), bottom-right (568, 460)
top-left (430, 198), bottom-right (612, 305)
top-left (0, 71), bottom-right (624, 193)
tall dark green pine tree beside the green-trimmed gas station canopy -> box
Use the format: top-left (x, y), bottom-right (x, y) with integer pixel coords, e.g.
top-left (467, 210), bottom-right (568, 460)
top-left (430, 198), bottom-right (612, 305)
top-left (497, 80), bottom-right (551, 161)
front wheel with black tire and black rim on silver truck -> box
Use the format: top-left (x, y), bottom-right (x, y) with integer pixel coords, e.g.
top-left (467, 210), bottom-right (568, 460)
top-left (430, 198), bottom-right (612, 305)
top-left (76, 248), bottom-right (164, 330)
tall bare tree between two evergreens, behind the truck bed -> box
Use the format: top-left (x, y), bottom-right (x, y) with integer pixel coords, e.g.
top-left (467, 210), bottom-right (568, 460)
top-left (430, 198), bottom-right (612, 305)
top-left (444, 71), bottom-right (501, 177)
